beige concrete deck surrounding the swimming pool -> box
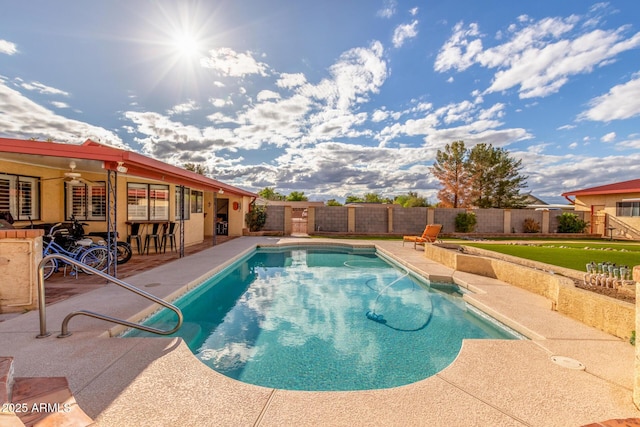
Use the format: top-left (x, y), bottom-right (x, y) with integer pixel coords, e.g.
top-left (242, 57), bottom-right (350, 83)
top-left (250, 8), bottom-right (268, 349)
top-left (0, 237), bottom-right (640, 427)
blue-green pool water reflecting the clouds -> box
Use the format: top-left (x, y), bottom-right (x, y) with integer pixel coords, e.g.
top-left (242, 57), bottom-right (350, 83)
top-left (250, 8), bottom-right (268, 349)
top-left (126, 247), bottom-right (518, 390)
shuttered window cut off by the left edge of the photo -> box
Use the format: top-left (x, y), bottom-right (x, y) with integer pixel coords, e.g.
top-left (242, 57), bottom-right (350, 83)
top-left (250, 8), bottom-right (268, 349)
top-left (0, 174), bottom-right (40, 221)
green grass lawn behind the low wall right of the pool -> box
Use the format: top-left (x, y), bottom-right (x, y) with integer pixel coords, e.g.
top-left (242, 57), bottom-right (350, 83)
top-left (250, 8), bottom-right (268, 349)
top-left (463, 240), bottom-right (640, 271)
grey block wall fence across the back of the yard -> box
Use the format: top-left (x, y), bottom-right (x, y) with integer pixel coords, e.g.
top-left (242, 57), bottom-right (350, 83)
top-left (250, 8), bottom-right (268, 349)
top-left (263, 205), bottom-right (590, 235)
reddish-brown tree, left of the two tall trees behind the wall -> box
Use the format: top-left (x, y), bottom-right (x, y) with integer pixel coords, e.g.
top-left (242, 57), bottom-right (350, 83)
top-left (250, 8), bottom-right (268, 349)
top-left (431, 141), bottom-right (469, 208)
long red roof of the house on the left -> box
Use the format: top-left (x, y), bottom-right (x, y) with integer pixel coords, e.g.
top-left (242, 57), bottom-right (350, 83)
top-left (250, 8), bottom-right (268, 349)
top-left (0, 138), bottom-right (258, 197)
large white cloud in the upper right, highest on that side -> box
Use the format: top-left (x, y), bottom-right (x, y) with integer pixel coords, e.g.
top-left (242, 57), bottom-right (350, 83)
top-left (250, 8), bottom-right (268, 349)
top-left (434, 10), bottom-right (640, 99)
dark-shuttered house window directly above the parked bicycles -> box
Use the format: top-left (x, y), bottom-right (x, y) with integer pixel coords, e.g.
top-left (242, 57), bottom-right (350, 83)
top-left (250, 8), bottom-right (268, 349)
top-left (65, 182), bottom-right (107, 221)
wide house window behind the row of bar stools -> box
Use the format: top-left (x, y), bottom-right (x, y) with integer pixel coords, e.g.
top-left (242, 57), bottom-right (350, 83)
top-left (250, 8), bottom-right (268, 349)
top-left (127, 182), bottom-right (169, 221)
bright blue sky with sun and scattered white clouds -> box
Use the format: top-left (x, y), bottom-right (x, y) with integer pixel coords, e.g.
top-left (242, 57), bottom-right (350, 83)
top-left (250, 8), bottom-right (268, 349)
top-left (0, 0), bottom-right (640, 203)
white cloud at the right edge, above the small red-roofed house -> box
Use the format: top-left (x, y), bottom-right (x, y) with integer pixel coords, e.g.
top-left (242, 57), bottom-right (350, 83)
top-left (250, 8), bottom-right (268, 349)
top-left (578, 74), bottom-right (640, 122)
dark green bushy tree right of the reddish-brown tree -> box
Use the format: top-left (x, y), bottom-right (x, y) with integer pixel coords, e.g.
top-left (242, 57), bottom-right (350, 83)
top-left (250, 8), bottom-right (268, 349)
top-left (467, 144), bottom-right (527, 208)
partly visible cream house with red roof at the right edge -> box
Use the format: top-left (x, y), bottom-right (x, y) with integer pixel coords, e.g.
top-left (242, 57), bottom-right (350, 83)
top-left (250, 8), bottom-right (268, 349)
top-left (562, 179), bottom-right (640, 240)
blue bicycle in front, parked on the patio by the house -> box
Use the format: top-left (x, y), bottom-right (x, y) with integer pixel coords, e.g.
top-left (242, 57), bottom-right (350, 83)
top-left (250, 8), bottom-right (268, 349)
top-left (42, 223), bottom-right (110, 280)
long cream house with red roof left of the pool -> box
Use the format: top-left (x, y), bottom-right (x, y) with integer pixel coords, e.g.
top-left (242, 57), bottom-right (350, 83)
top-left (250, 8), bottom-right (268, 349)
top-left (0, 138), bottom-right (257, 250)
